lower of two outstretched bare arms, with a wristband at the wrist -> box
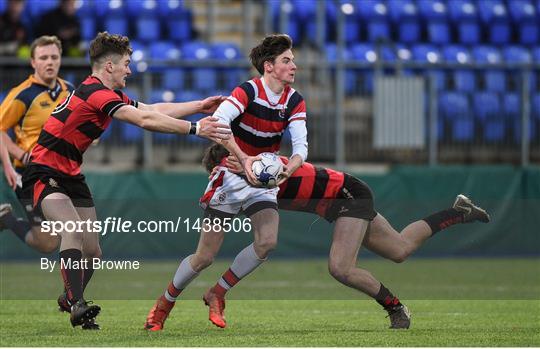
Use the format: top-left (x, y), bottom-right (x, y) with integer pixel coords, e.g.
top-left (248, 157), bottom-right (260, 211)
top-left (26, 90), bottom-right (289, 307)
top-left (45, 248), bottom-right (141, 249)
top-left (114, 105), bottom-right (231, 141)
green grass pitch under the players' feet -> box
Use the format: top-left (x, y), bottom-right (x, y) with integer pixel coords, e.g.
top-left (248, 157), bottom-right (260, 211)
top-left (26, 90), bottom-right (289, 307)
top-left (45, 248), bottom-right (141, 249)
top-left (0, 259), bottom-right (540, 346)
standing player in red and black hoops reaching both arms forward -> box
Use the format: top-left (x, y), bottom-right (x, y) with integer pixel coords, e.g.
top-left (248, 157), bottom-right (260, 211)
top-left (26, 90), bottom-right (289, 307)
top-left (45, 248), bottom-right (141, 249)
top-left (23, 32), bottom-right (230, 329)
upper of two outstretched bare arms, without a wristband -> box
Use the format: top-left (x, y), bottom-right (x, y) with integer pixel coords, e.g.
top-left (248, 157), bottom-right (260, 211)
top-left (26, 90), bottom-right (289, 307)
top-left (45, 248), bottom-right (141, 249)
top-left (139, 96), bottom-right (226, 119)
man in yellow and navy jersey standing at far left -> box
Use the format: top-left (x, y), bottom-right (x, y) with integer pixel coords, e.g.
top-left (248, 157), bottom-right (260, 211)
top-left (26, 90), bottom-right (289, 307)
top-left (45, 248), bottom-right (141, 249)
top-left (0, 36), bottom-right (74, 253)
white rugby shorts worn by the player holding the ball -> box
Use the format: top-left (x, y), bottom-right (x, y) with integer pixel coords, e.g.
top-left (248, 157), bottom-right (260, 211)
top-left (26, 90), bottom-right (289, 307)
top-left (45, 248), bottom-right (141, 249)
top-left (199, 167), bottom-right (279, 215)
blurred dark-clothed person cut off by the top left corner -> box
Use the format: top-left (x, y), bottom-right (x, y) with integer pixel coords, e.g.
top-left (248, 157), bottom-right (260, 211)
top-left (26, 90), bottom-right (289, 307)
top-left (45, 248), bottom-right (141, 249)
top-left (0, 0), bottom-right (28, 56)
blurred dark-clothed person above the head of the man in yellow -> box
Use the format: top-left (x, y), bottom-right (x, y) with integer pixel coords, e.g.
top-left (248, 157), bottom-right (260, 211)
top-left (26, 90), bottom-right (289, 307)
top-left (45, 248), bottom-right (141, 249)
top-left (35, 0), bottom-right (83, 57)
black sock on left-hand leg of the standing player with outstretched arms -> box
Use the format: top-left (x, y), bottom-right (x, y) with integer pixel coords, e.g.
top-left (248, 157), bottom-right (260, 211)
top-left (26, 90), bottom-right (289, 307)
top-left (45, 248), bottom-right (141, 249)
top-left (60, 248), bottom-right (83, 304)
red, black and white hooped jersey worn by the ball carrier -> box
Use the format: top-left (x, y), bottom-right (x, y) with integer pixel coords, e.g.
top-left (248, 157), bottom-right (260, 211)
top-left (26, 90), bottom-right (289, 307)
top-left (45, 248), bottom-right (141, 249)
top-left (227, 78), bottom-right (306, 156)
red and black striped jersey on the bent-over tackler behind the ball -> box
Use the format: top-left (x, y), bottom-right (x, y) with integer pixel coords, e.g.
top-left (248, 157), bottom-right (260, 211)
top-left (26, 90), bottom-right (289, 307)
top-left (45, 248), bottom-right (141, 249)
top-left (278, 157), bottom-right (345, 217)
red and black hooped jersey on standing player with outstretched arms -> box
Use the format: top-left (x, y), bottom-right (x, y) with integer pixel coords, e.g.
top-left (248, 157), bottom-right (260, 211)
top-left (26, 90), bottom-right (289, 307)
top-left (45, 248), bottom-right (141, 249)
top-left (32, 76), bottom-right (137, 176)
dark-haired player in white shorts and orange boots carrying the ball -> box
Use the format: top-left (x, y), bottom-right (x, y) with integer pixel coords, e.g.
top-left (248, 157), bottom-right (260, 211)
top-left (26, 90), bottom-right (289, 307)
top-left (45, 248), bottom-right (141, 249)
top-left (145, 34), bottom-right (308, 331)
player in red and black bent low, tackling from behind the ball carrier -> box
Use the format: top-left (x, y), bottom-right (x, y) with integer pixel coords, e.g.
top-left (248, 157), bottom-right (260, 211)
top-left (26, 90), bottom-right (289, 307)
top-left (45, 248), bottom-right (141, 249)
top-left (143, 144), bottom-right (489, 330)
